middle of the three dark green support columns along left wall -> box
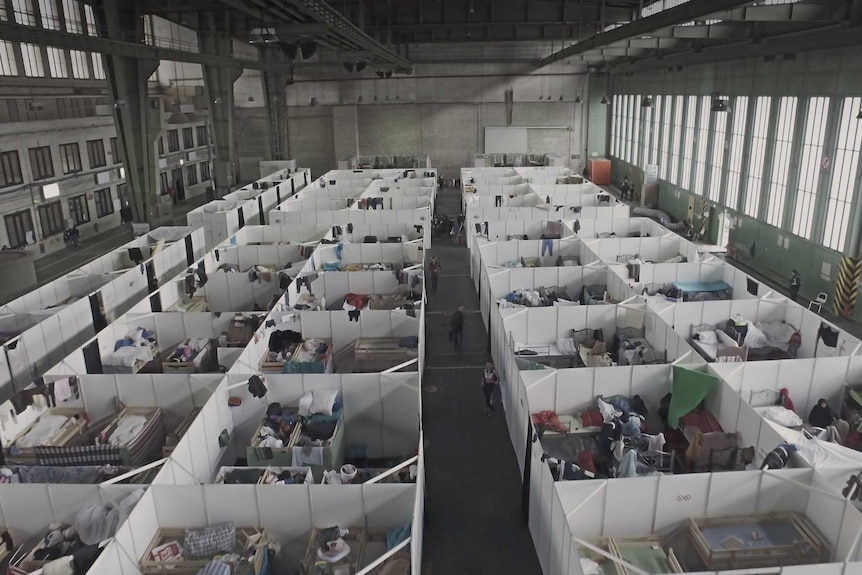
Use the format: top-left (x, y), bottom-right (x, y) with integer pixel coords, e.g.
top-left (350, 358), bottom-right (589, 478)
top-left (198, 12), bottom-right (242, 198)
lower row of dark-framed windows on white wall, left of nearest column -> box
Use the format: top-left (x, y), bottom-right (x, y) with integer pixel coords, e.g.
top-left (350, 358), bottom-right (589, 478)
top-left (4, 188), bottom-right (114, 247)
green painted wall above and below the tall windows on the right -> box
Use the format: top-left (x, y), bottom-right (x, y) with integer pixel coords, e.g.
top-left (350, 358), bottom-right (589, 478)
top-left (590, 46), bottom-right (862, 321)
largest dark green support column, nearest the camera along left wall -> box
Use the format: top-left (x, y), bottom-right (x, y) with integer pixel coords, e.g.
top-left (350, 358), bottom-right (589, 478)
top-left (93, 0), bottom-right (162, 224)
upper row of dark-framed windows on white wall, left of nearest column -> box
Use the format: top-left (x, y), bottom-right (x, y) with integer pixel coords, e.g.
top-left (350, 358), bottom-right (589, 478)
top-left (0, 138), bottom-right (120, 188)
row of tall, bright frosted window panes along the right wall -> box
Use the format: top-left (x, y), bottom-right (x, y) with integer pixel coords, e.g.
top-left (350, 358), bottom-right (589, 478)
top-left (611, 95), bottom-right (862, 250)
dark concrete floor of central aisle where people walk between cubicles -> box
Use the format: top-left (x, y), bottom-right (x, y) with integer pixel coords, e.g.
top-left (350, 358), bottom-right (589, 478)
top-left (422, 183), bottom-right (541, 575)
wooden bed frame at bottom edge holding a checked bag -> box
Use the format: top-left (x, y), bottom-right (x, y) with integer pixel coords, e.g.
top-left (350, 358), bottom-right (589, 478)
top-left (140, 527), bottom-right (271, 575)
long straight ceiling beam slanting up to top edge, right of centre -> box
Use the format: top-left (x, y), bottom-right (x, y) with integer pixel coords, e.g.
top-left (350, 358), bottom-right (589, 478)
top-left (536, 0), bottom-right (768, 68)
